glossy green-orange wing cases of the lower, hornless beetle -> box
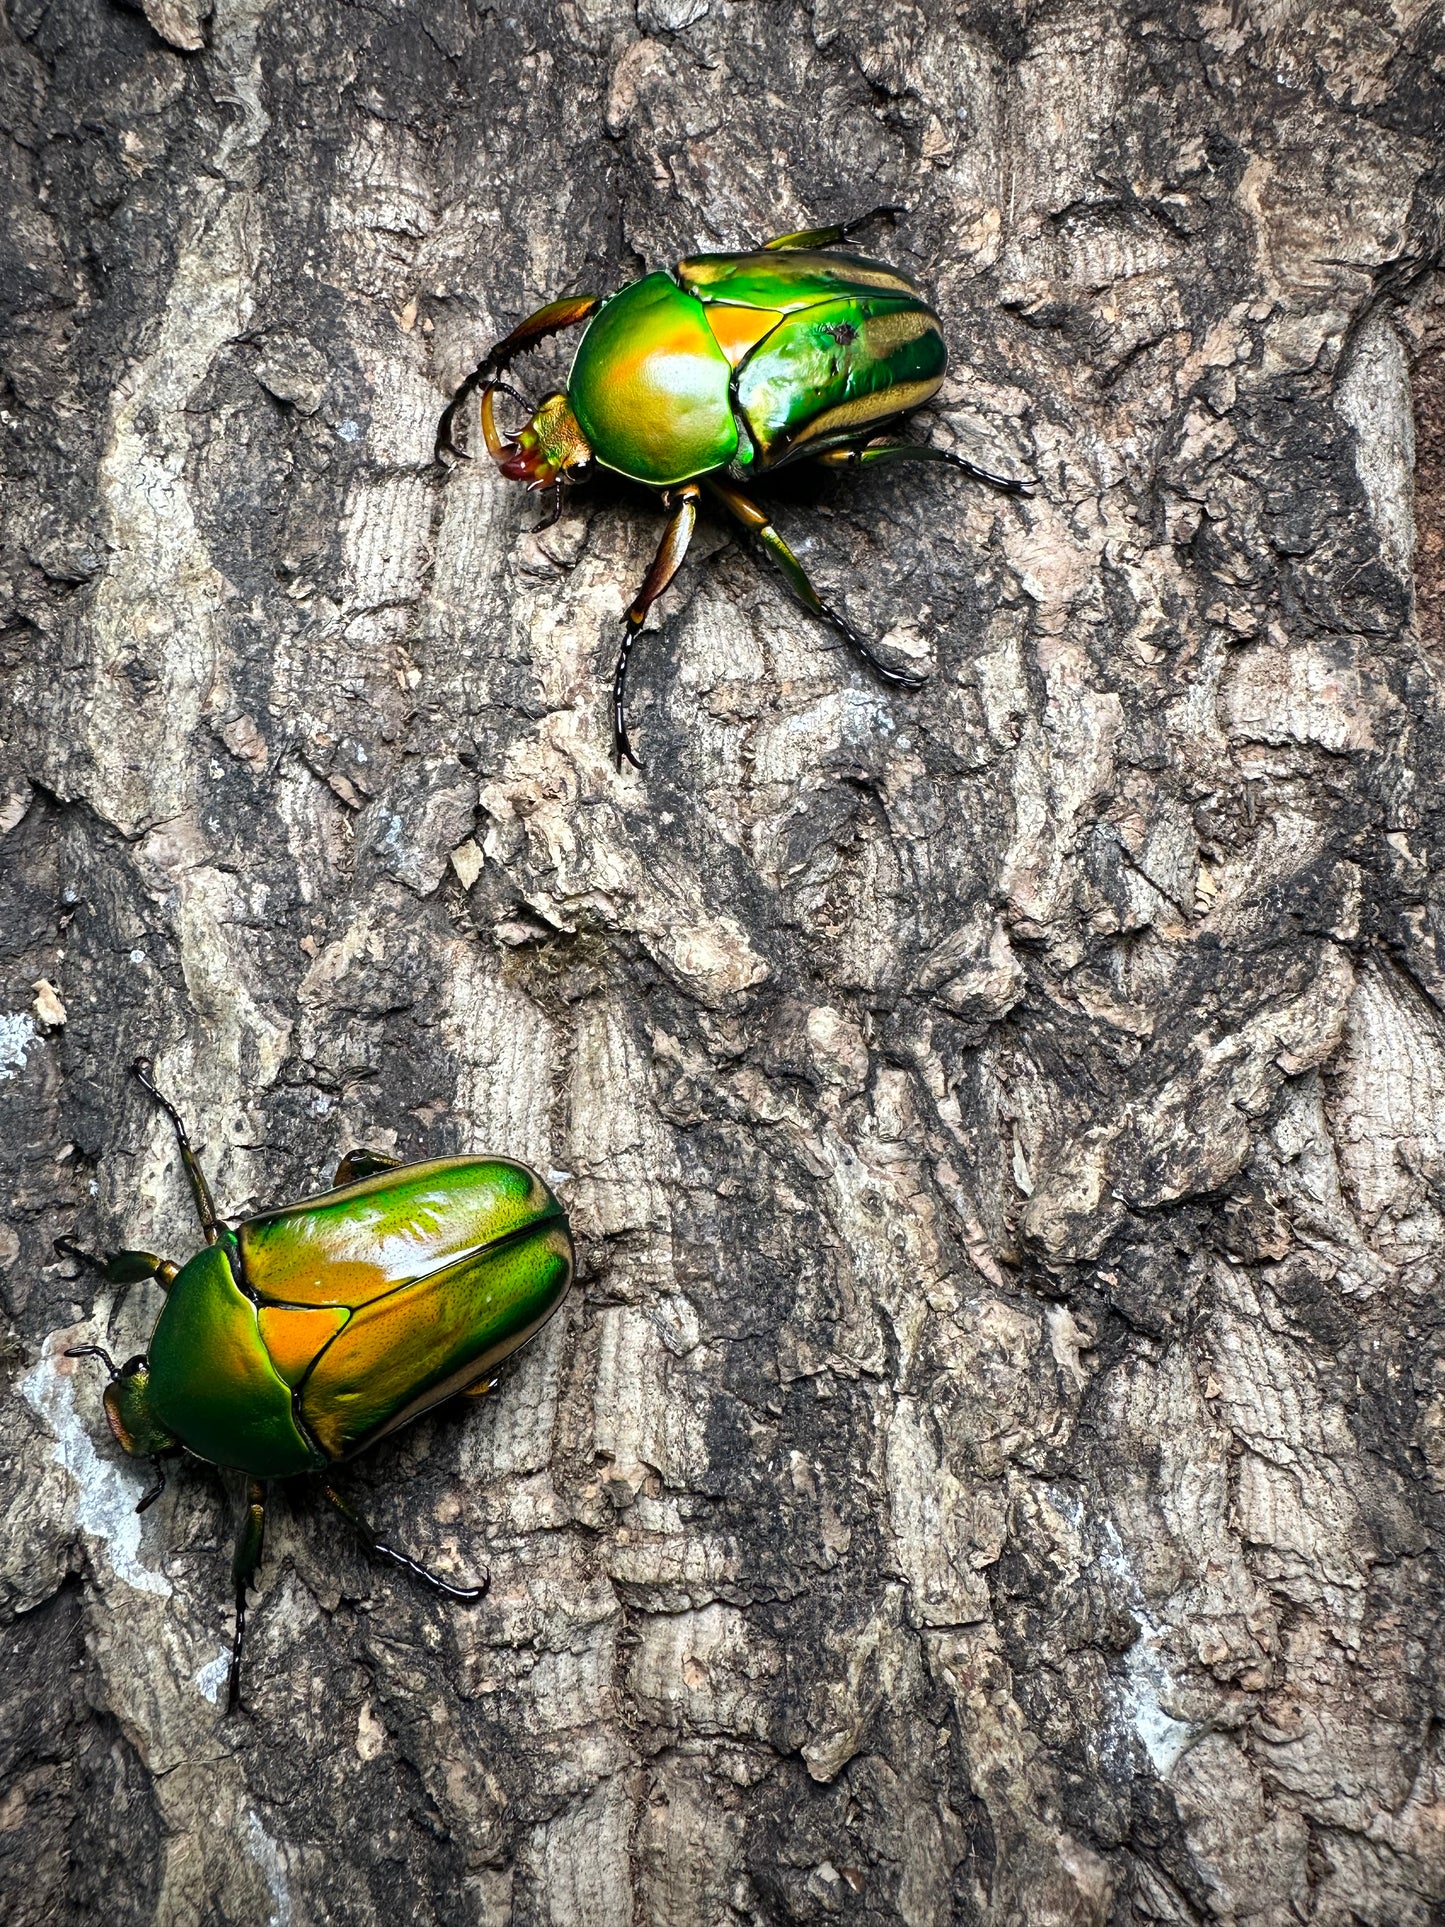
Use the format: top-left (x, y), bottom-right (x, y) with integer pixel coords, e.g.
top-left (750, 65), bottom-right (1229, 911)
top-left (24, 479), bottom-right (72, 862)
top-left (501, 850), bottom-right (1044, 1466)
top-left (240, 1158), bottom-right (572, 1459)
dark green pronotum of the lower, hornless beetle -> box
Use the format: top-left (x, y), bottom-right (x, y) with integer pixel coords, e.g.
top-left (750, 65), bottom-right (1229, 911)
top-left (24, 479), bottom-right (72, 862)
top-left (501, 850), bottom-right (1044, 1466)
top-left (146, 1239), bottom-right (324, 1478)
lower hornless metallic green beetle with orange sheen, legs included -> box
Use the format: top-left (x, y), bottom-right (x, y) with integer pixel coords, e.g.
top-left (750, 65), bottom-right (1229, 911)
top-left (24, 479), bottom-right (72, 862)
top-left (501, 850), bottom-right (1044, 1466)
top-left (60, 1058), bottom-right (574, 1711)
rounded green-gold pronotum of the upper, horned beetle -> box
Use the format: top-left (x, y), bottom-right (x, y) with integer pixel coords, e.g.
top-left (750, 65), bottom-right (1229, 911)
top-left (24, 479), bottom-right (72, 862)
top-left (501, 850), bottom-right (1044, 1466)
top-left (566, 274), bottom-right (738, 488)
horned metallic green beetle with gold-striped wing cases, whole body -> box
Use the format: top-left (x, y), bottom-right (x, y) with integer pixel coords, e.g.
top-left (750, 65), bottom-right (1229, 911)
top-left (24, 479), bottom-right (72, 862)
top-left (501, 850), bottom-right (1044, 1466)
top-left (437, 206), bottom-right (1029, 769)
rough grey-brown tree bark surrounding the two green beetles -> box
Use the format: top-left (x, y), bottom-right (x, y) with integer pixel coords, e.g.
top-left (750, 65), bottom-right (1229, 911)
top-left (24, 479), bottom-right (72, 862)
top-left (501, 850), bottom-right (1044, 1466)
top-left (0, 0), bottom-right (1445, 1927)
